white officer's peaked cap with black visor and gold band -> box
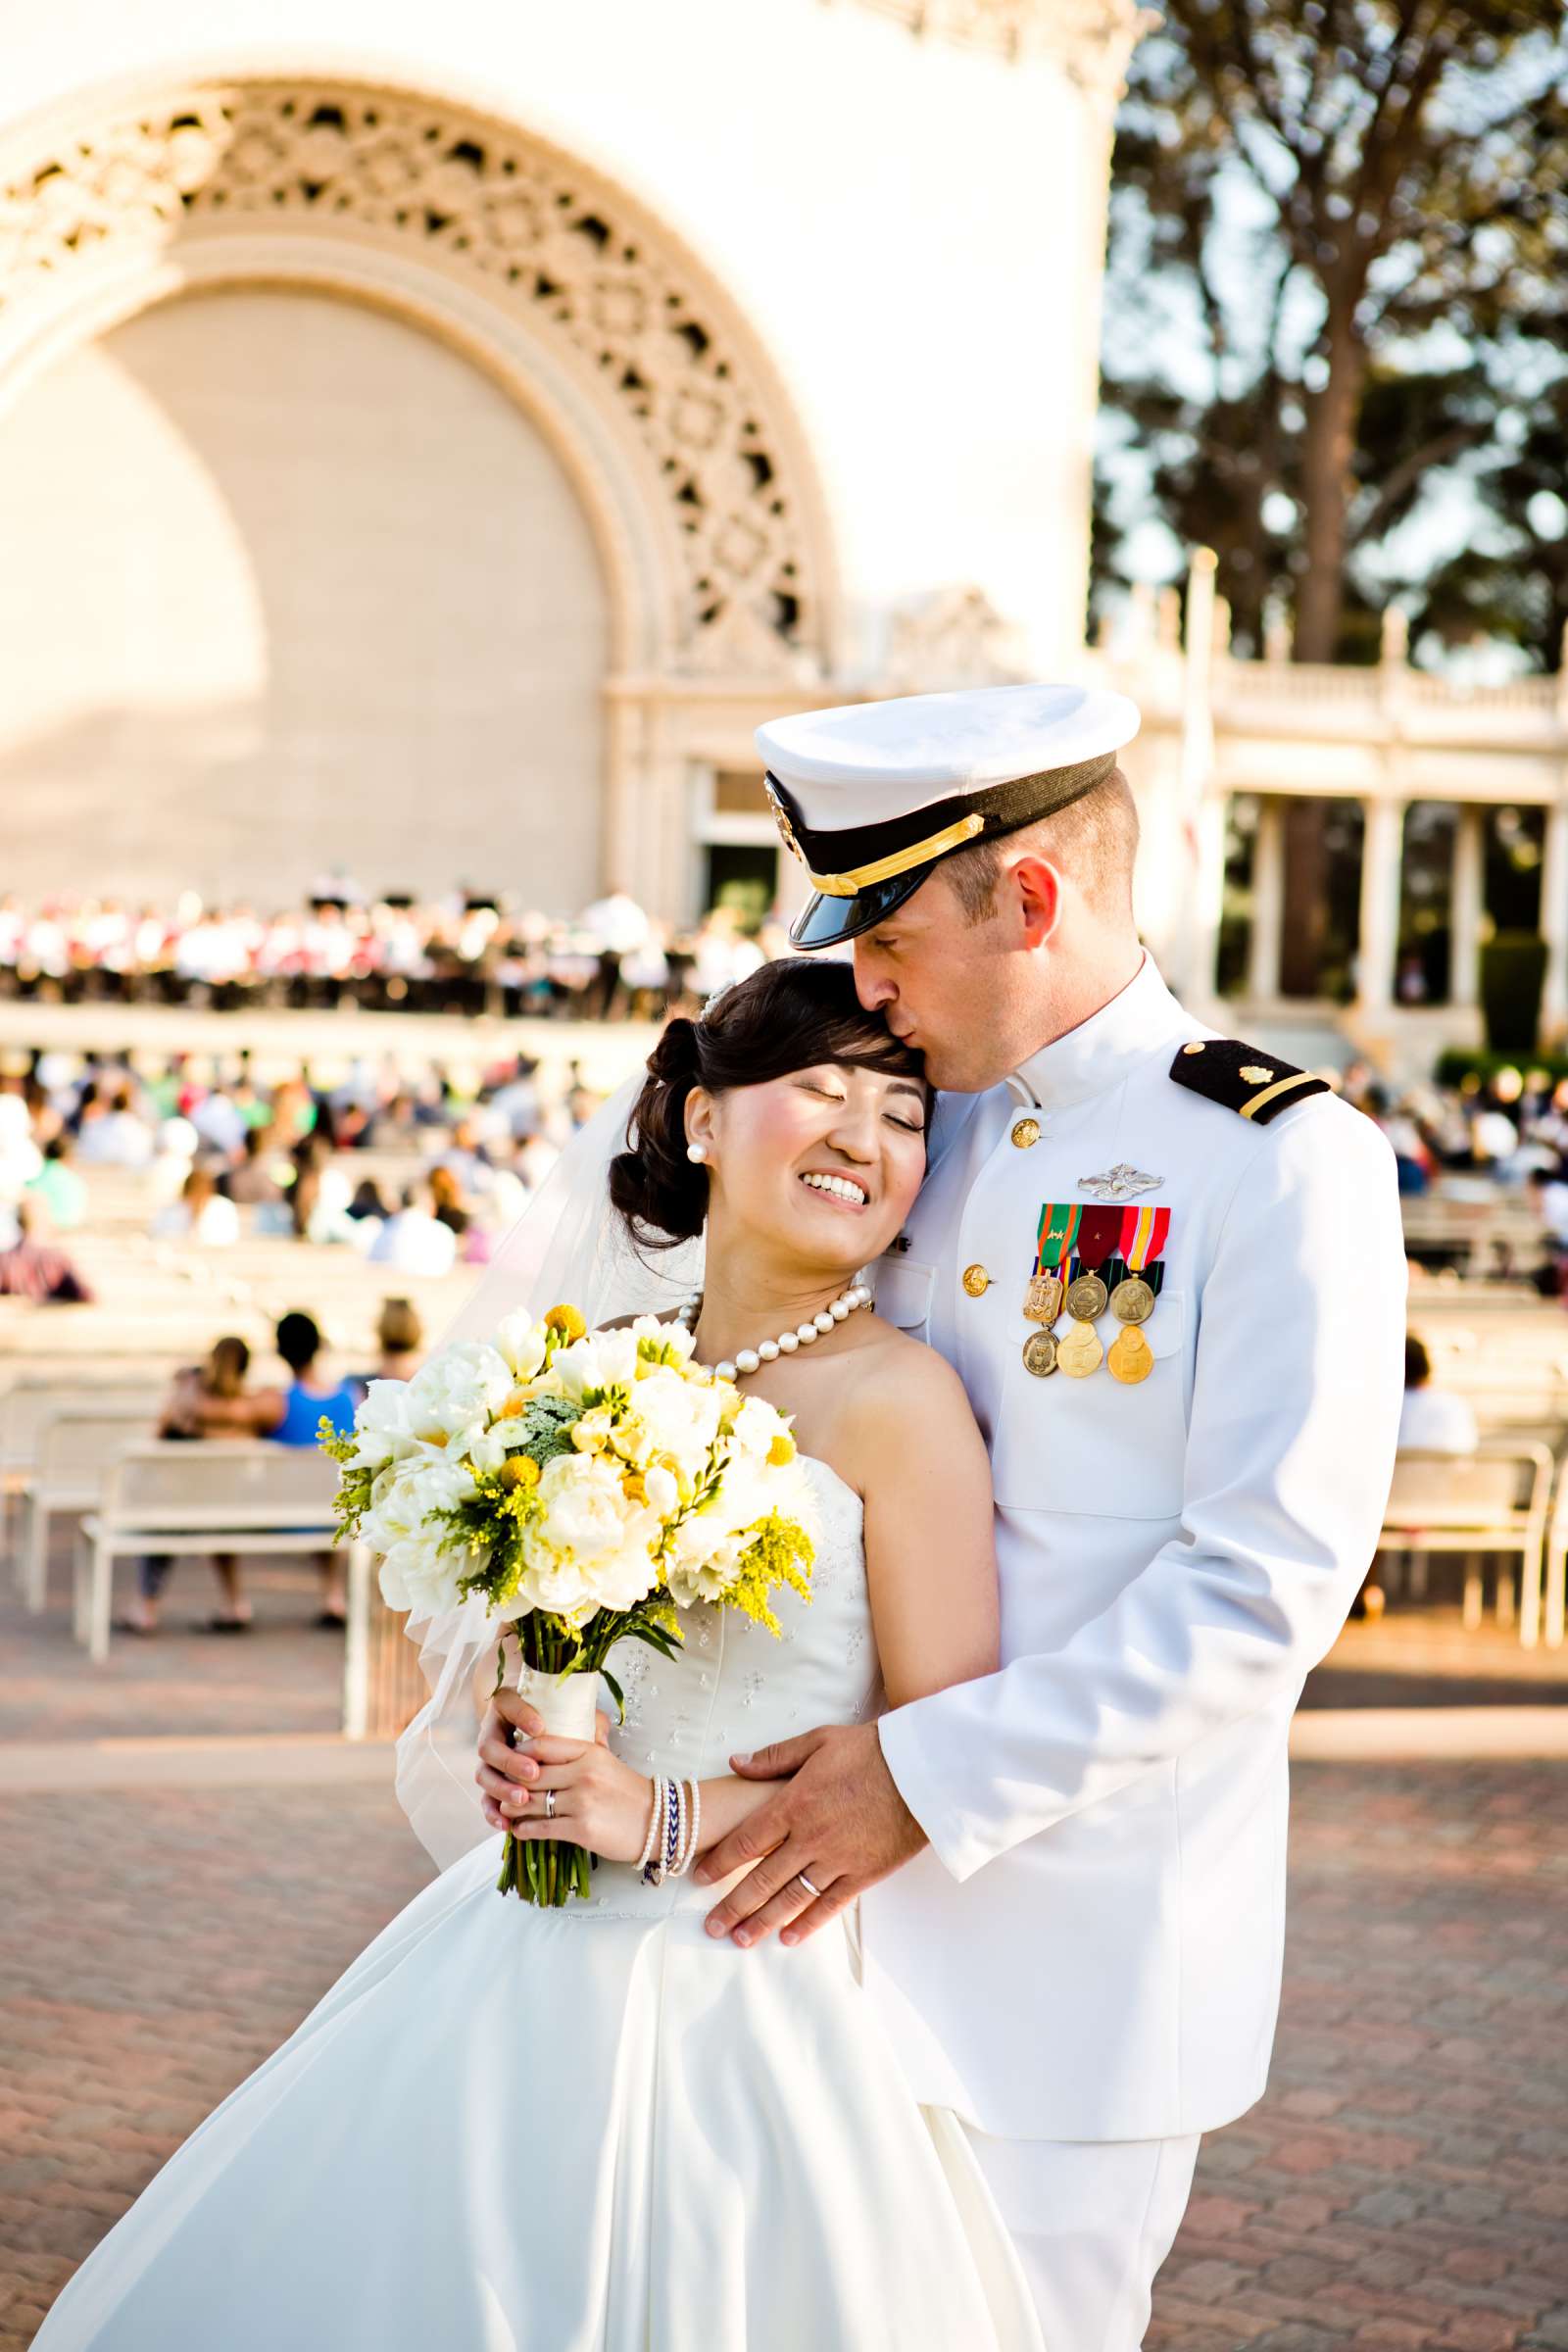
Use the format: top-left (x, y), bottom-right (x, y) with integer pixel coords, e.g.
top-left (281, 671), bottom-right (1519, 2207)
top-left (757, 687), bottom-right (1138, 948)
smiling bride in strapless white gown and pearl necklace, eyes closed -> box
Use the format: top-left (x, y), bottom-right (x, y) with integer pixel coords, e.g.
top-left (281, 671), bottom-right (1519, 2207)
top-left (35, 962), bottom-right (1039, 2352)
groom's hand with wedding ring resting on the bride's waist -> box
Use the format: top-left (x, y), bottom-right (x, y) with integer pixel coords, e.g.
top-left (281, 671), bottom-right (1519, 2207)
top-left (696, 1724), bottom-right (926, 1942)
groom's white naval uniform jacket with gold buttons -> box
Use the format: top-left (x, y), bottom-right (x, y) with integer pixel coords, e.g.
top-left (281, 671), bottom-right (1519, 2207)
top-left (860, 962), bottom-right (1405, 2140)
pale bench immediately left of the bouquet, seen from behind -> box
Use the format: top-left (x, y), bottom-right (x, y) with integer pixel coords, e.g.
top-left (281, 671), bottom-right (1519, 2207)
top-left (75, 1440), bottom-right (360, 1665)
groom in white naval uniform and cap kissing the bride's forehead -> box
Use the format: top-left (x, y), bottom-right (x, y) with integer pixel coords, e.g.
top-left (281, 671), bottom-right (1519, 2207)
top-left (484, 687), bottom-right (1403, 2352)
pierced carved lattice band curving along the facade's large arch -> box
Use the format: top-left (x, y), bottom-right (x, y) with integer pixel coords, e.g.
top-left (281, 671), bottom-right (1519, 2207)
top-left (0, 77), bottom-right (825, 675)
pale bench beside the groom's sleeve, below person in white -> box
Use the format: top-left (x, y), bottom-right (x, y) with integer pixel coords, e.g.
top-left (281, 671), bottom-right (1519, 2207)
top-left (1378, 1437), bottom-right (1554, 1646)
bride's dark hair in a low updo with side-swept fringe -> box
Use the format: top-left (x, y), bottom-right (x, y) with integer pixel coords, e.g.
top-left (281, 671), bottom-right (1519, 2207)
top-left (609, 955), bottom-right (926, 1249)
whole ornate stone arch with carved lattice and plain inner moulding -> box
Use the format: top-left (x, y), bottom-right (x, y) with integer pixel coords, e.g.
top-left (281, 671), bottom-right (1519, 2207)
top-left (0, 75), bottom-right (835, 677)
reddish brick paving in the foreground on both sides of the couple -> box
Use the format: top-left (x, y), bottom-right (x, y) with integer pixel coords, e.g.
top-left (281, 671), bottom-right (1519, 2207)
top-left (0, 1764), bottom-right (1568, 2352)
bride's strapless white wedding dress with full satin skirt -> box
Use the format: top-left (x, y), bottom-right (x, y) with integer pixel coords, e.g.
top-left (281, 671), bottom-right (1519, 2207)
top-left (35, 1463), bottom-right (1042, 2352)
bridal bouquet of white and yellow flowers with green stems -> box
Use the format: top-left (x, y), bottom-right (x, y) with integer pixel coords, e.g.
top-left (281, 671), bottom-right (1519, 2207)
top-left (322, 1305), bottom-right (813, 1905)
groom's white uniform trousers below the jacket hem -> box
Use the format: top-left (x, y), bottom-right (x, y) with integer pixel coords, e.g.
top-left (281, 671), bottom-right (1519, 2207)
top-left (968, 2131), bottom-right (1199, 2352)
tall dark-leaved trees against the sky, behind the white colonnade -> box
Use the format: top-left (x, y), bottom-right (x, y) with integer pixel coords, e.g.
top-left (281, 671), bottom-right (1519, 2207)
top-left (1096, 0), bottom-right (1568, 661)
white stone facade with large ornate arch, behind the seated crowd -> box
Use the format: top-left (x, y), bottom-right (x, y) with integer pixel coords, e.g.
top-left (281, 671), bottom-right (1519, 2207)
top-left (0, 0), bottom-right (1138, 917)
